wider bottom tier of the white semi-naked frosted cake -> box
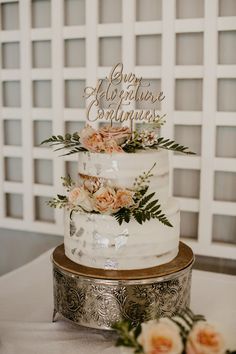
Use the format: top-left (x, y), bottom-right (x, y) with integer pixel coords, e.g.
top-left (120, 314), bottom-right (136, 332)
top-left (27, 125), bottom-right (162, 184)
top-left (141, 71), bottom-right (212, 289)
top-left (64, 198), bottom-right (180, 270)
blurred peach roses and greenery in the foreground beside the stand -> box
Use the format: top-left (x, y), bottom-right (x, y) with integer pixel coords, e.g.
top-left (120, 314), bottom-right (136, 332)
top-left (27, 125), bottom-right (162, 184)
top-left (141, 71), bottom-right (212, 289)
top-left (113, 309), bottom-right (236, 354)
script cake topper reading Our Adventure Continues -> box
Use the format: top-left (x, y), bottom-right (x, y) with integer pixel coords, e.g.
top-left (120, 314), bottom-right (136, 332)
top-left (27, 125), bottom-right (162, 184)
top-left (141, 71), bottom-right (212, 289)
top-left (84, 63), bottom-right (165, 127)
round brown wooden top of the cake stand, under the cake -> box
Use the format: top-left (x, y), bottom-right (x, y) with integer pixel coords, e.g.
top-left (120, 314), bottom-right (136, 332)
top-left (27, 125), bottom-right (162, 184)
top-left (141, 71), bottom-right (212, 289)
top-left (52, 242), bottom-right (194, 280)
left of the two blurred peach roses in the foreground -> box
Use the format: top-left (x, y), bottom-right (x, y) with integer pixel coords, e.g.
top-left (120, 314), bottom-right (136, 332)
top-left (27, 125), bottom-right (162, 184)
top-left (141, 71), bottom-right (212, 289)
top-left (138, 318), bottom-right (183, 354)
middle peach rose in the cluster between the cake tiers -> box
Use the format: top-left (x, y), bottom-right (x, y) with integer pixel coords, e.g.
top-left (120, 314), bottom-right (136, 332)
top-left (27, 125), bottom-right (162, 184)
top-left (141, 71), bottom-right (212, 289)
top-left (93, 187), bottom-right (116, 214)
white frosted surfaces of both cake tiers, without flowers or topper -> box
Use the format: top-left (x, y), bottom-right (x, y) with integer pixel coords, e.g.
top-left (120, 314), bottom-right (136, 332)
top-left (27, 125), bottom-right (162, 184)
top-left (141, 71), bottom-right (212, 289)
top-left (64, 149), bottom-right (180, 270)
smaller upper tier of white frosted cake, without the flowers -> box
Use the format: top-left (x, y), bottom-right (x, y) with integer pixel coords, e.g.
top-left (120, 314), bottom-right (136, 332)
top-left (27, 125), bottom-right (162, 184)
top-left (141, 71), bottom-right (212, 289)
top-left (78, 150), bottom-right (169, 204)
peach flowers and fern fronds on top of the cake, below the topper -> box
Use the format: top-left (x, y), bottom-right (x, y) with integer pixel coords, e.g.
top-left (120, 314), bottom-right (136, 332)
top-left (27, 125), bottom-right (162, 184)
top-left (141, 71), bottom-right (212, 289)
top-left (42, 121), bottom-right (194, 155)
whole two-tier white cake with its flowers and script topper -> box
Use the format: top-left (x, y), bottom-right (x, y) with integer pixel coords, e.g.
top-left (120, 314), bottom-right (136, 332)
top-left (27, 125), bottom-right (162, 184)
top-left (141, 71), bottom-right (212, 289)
top-left (43, 63), bottom-right (193, 270)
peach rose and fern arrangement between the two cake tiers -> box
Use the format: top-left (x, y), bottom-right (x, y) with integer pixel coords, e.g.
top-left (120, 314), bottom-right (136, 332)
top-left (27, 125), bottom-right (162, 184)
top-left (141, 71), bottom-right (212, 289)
top-left (48, 164), bottom-right (172, 227)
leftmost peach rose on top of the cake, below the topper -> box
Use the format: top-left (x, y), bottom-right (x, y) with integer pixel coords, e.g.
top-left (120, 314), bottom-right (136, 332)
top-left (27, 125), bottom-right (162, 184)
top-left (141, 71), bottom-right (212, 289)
top-left (80, 125), bottom-right (105, 152)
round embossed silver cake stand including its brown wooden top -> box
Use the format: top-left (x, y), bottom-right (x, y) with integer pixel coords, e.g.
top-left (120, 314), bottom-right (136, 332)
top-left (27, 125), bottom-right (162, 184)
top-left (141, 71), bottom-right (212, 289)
top-left (52, 242), bottom-right (194, 330)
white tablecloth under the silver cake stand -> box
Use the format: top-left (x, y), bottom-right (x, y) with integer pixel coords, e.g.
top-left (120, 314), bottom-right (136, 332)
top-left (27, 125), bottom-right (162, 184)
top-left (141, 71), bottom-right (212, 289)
top-left (0, 250), bottom-right (236, 354)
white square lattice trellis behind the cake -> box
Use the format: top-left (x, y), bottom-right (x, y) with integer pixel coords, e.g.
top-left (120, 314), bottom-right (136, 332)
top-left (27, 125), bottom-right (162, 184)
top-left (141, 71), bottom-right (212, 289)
top-left (0, 0), bottom-right (236, 258)
